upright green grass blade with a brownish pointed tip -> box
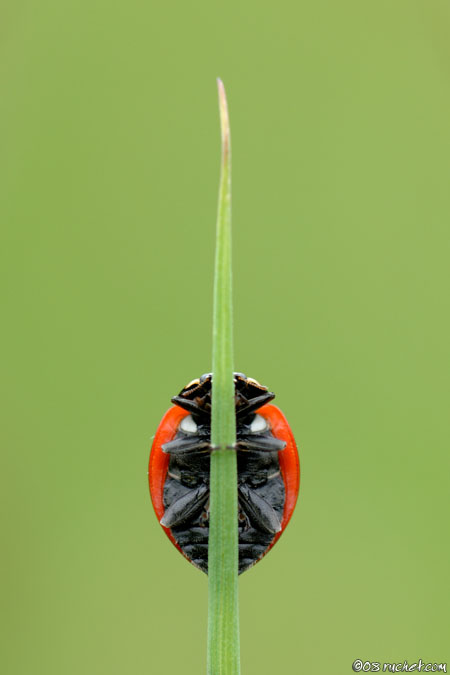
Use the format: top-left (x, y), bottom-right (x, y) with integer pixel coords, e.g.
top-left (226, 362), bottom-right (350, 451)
top-left (207, 80), bottom-right (240, 675)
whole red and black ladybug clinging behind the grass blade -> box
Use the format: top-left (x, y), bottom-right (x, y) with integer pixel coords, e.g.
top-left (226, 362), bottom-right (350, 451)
top-left (149, 373), bottom-right (300, 574)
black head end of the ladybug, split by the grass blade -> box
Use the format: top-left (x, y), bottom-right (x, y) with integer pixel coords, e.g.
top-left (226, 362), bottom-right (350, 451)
top-left (172, 373), bottom-right (275, 418)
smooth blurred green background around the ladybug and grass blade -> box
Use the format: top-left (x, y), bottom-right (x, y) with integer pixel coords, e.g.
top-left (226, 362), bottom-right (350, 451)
top-left (0, 0), bottom-right (450, 675)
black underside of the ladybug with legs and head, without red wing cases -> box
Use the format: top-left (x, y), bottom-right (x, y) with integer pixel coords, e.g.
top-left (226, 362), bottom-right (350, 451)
top-left (161, 373), bottom-right (285, 573)
